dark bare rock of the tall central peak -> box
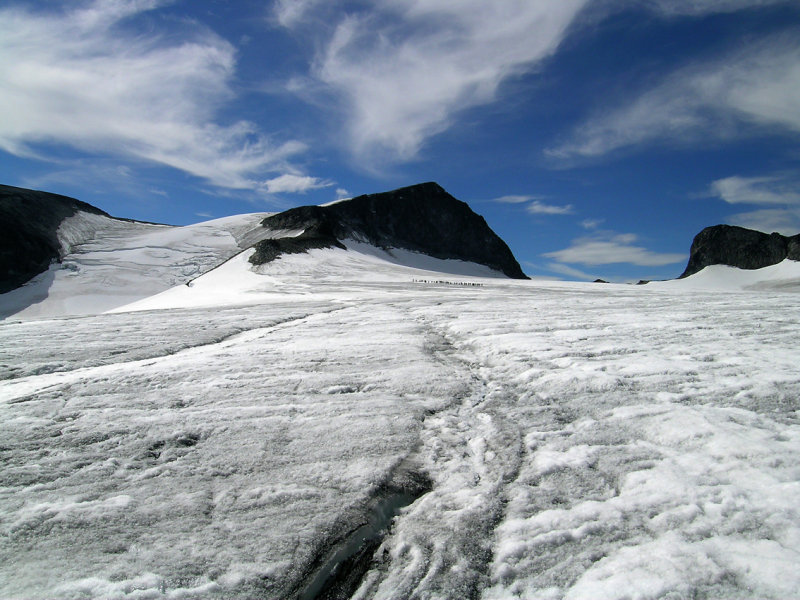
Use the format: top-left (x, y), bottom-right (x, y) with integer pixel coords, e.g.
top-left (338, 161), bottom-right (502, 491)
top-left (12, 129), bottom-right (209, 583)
top-left (250, 182), bottom-right (527, 279)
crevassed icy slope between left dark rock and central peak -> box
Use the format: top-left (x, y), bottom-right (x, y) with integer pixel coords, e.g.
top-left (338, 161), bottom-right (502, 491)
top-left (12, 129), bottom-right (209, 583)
top-left (0, 212), bottom-right (266, 318)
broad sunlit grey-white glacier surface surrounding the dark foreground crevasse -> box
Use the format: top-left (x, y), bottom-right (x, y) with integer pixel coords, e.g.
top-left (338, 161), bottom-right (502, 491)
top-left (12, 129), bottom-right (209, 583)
top-left (0, 251), bottom-right (800, 599)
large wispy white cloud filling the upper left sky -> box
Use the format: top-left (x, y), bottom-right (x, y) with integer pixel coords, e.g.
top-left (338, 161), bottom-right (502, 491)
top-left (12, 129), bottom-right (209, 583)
top-left (0, 0), bottom-right (305, 188)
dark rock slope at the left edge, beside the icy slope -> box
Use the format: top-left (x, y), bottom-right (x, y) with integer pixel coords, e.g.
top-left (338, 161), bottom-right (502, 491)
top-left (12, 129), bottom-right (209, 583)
top-left (0, 185), bottom-right (108, 293)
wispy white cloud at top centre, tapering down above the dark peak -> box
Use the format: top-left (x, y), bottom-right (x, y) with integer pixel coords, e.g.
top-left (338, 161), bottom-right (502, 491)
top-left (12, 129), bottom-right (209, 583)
top-left (284, 0), bottom-right (588, 162)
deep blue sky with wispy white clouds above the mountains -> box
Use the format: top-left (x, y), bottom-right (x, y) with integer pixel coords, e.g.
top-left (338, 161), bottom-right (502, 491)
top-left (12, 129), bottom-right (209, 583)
top-left (0, 0), bottom-right (800, 281)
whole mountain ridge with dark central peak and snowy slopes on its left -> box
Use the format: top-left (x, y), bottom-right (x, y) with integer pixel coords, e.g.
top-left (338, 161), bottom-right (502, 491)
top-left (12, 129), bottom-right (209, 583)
top-left (0, 184), bottom-right (525, 318)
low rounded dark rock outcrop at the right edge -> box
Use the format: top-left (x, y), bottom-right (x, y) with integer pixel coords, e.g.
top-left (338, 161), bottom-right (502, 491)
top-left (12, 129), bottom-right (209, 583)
top-left (681, 225), bottom-right (800, 277)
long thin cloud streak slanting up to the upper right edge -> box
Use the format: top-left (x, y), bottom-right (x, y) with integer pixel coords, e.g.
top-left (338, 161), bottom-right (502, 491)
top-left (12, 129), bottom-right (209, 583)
top-left (547, 37), bottom-right (800, 159)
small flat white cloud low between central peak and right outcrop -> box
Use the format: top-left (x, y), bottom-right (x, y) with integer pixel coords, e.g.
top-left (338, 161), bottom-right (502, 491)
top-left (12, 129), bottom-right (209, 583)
top-left (543, 233), bottom-right (687, 267)
